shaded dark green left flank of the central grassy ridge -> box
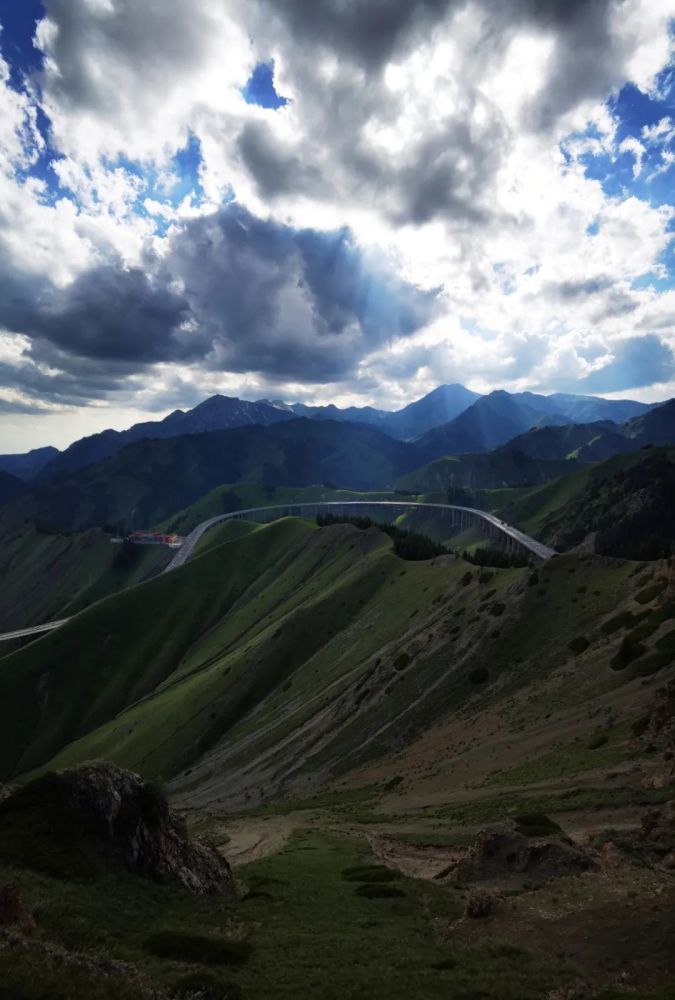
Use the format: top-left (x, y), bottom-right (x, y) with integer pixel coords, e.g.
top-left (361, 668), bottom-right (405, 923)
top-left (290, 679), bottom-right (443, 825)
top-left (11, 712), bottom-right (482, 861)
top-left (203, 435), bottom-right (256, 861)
top-left (0, 522), bottom-right (311, 771)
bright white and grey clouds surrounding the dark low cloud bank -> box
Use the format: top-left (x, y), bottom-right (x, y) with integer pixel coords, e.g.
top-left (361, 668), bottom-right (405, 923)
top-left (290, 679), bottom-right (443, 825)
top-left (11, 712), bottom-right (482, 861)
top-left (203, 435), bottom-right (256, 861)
top-left (0, 0), bottom-right (675, 446)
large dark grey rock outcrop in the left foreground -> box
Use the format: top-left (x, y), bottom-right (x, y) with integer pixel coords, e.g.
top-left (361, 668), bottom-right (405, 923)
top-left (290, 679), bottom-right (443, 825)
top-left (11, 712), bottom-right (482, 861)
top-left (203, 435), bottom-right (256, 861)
top-left (0, 761), bottom-right (235, 896)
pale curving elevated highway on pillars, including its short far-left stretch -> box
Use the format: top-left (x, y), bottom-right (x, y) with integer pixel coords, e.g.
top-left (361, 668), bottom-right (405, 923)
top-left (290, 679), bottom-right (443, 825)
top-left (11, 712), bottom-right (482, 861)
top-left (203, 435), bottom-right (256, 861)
top-left (0, 500), bottom-right (555, 642)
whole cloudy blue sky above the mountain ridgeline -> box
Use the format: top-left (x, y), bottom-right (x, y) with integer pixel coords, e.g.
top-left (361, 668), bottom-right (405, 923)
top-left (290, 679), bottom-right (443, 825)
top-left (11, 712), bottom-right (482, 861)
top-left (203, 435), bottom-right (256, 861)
top-left (0, 0), bottom-right (675, 452)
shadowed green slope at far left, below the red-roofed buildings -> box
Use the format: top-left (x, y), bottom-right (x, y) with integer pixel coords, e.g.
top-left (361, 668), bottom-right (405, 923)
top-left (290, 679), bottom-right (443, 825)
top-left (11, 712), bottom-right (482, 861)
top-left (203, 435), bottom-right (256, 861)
top-left (0, 524), bottom-right (170, 632)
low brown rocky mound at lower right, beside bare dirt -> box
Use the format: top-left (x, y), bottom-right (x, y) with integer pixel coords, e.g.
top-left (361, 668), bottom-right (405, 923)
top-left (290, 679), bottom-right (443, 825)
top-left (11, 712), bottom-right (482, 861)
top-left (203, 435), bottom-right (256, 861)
top-left (452, 830), bottom-right (596, 885)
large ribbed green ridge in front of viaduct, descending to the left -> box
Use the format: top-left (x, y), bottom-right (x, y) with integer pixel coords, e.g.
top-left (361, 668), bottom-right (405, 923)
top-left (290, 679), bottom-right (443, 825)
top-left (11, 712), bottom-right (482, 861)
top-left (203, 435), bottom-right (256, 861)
top-left (0, 519), bottom-right (668, 828)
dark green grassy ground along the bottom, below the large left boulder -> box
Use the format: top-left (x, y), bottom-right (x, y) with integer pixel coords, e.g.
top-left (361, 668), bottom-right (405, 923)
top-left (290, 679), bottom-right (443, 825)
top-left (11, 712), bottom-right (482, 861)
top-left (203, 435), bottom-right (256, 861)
top-left (0, 831), bottom-right (596, 1000)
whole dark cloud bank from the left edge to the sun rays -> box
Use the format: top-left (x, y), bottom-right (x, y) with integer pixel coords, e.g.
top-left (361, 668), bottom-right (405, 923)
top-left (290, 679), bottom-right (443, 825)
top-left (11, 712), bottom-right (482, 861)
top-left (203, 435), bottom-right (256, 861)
top-left (0, 206), bottom-right (436, 403)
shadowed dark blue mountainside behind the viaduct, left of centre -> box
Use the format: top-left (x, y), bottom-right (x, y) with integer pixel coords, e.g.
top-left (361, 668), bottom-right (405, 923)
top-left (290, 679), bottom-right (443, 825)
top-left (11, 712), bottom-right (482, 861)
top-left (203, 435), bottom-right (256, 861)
top-left (0, 419), bottom-right (419, 534)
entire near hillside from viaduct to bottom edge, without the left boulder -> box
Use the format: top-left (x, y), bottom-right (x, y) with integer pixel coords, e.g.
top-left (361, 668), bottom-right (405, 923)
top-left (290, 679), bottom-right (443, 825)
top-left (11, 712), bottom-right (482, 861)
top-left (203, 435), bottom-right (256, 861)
top-left (0, 512), bottom-right (675, 1000)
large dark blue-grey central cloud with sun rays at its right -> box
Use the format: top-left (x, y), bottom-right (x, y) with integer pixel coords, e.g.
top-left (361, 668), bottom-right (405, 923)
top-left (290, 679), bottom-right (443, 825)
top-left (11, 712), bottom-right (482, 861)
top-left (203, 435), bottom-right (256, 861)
top-left (169, 206), bottom-right (436, 381)
